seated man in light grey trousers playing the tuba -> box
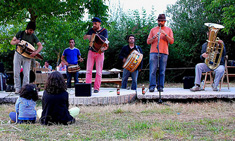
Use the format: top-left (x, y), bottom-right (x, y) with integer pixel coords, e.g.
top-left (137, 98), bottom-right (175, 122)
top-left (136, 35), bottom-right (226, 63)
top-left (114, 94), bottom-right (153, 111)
top-left (190, 32), bottom-right (226, 92)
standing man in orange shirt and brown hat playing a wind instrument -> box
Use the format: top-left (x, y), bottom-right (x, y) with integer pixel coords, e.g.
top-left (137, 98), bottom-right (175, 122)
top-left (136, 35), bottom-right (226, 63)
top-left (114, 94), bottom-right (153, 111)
top-left (147, 14), bottom-right (174, 92)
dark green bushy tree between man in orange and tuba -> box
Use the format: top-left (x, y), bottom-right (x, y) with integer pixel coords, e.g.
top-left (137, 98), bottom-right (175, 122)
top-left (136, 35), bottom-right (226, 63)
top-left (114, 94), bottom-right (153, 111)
top-left (167, 0), bottom-right (207, 67)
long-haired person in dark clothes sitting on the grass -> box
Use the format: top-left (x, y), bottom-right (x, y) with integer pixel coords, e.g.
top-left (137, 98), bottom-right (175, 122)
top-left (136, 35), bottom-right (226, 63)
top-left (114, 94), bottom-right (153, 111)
top-left (37, 71), bottom-right (79, 125)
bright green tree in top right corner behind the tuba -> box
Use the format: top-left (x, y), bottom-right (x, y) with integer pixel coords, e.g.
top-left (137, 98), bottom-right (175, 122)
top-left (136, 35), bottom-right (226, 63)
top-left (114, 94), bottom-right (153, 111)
top-left (203, 0), bottom-right (235, 57)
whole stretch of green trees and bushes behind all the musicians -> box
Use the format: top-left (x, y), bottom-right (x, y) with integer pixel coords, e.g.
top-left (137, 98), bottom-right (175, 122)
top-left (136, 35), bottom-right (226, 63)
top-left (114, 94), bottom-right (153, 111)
top-left (0, 0), bottom-right (235, 81)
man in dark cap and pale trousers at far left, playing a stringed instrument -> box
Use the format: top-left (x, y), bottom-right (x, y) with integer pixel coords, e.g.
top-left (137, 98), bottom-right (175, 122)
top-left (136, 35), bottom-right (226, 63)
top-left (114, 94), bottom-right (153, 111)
top-left (11, 21), bottom-right (43, 94)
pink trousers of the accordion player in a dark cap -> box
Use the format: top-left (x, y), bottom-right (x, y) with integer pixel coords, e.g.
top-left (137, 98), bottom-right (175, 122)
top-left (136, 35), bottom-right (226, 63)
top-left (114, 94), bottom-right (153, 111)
top-left (86, 50), bottom-right (104, 90)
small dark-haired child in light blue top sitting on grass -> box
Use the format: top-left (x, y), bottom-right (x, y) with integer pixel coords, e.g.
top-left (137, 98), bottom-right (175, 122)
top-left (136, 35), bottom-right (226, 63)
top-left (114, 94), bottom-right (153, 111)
top-left (9, 84), bottom-right (38, 123)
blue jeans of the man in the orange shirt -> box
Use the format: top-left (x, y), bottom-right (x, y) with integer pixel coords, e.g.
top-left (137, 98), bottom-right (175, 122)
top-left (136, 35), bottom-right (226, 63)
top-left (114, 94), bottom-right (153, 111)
top-left (149, 53), bottom-right (168, 89)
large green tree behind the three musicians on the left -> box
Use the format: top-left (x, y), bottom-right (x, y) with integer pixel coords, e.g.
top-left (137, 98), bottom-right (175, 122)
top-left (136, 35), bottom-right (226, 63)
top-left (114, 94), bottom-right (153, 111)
top-left (0, 0), bottom-right (108, 70)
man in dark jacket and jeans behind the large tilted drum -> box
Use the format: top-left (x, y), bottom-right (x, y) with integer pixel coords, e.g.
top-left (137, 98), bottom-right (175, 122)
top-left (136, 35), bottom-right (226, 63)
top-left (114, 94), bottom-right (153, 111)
top-left (119, 34), bottom-right (143, 90)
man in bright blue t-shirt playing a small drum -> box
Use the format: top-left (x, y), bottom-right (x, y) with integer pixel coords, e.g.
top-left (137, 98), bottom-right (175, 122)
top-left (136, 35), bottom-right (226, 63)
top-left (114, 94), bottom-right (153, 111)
top-left (61, 38), bottom-right (83, 88)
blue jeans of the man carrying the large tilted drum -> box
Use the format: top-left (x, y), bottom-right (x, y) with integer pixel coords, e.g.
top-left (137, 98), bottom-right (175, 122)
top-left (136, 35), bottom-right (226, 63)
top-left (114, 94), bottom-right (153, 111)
top-left (121, 69), bottom-right (139, 90)
